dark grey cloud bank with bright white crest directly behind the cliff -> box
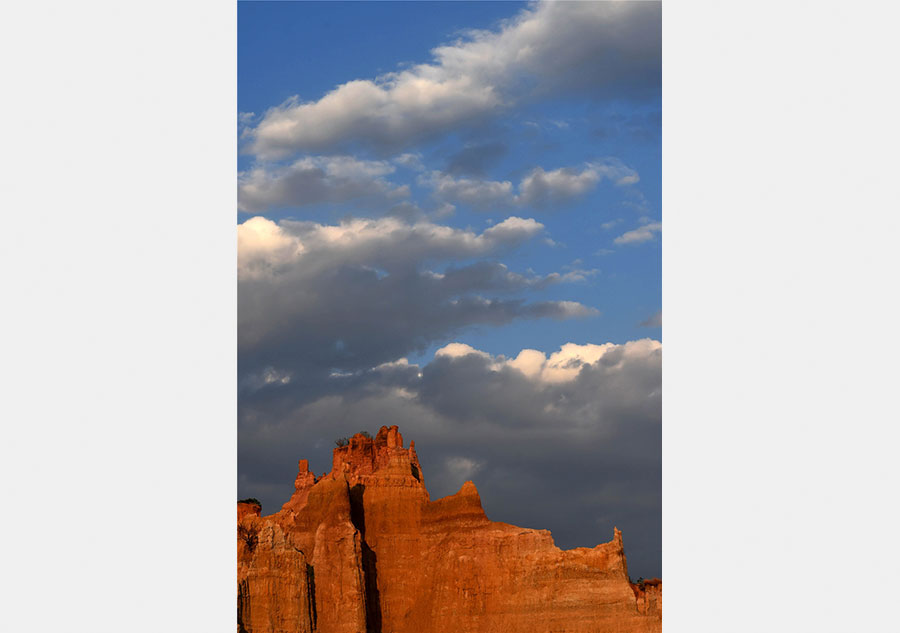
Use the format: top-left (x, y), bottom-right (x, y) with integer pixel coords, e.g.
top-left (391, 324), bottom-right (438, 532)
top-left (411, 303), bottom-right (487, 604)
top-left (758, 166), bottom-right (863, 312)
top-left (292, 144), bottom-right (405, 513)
top-left (239, 339), bottom-right (662, 576)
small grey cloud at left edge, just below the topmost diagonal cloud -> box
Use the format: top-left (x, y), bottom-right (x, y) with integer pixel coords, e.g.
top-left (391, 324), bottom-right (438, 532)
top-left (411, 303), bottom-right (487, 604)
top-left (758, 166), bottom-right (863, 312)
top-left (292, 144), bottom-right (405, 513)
top-left (238, 156), bottom-right (409, 213)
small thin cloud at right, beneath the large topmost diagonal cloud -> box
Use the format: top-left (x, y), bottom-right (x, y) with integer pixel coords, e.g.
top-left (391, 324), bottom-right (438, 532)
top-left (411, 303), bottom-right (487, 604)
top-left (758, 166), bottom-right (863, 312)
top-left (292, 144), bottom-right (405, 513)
top-left (419, 158), bottom-right (639, 210)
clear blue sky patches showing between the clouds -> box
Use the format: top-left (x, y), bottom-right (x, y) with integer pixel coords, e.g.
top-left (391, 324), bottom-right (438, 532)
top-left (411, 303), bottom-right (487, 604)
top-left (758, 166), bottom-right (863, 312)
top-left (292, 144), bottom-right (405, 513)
top-left (238, 2), bottom-right (661, 357)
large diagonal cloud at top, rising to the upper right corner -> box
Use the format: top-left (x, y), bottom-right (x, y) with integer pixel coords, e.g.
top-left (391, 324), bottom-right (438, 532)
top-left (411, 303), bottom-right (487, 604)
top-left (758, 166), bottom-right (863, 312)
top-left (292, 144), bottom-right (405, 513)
top-left (247, 2), bottom-right (661, 159)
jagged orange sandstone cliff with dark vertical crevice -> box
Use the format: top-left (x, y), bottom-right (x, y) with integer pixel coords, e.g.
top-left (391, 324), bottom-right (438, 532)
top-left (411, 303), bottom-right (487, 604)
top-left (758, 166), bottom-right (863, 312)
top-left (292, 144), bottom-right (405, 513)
top-left (238, 426), bottom-right (662, 633)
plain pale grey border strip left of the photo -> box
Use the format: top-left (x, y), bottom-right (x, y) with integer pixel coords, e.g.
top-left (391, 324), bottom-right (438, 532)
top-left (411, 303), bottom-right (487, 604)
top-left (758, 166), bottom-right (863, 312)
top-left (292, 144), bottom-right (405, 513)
top-left (0, 1), bottom-right (237, 633)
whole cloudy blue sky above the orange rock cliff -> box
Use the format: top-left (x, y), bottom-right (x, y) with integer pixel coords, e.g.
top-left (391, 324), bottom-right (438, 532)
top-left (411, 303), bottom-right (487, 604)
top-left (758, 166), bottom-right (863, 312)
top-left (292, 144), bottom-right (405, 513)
top-left (237, 1), bottom-right (662, 578)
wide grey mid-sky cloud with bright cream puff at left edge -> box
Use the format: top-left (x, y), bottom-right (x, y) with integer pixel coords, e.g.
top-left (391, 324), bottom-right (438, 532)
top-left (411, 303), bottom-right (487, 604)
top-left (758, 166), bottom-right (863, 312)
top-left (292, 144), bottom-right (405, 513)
top-left (238, 216), bottom-right (597, 384)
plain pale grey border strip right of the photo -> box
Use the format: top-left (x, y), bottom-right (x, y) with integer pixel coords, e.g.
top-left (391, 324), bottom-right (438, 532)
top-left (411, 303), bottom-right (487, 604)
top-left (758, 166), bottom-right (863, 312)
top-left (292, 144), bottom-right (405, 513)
top-left (663, 1), bottom-right (900, 633)
